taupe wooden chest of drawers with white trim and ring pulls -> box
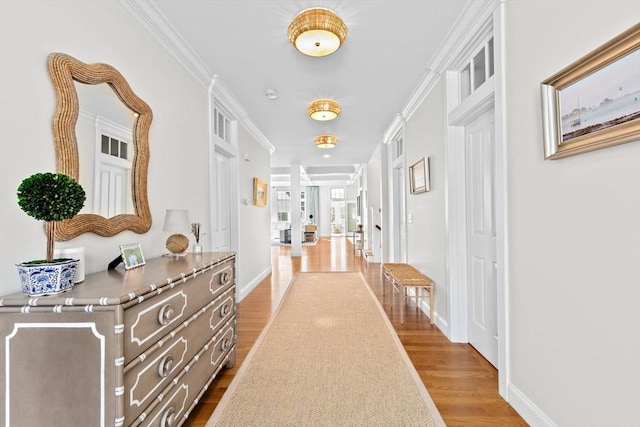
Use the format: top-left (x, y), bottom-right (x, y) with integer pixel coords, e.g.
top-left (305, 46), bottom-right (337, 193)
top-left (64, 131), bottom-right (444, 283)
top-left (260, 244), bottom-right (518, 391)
top-left (0, 252), bottom-right (236, 427)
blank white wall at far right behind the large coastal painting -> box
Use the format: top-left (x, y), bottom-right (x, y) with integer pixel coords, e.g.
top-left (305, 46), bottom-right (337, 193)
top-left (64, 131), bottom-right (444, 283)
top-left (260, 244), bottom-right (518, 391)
top-left (505, 0), bottom-right (640, 426)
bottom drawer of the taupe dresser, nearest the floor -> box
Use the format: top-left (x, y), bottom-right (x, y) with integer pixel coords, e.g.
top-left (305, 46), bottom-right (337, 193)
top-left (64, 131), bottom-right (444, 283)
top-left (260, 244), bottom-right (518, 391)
top-left (134, 321), bottom-right (235, 427)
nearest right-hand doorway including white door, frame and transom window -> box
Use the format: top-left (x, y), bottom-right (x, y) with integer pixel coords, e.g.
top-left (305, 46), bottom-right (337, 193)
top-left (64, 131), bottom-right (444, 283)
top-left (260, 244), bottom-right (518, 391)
top-left (445, 5), bottom-right (509, 398)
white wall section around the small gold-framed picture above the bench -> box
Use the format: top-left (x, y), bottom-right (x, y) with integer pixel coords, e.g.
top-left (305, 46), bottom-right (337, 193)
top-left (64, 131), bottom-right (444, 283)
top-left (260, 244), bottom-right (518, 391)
top-left (405, 80), bottom-right (449, 323)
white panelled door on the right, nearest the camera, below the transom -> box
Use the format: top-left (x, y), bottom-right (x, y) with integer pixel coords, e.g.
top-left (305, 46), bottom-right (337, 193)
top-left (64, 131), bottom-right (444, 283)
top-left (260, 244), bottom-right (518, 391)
top-left (465, 111), bottom-right (498, 367)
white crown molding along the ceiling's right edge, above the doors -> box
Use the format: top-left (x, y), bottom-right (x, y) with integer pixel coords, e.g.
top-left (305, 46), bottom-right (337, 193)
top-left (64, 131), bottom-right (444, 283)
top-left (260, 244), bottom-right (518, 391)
top-left (396, 0), bottom-right (505, 122)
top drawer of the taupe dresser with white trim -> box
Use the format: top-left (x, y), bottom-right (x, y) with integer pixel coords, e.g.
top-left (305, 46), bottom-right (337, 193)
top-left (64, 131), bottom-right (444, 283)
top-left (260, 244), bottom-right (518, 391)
top-left (124, 262), bottom-right (235, 364)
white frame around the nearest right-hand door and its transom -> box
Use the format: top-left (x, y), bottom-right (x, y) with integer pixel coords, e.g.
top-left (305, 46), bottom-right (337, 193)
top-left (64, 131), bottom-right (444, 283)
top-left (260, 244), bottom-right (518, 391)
top-left (445, 6), bottom-right (510, 401)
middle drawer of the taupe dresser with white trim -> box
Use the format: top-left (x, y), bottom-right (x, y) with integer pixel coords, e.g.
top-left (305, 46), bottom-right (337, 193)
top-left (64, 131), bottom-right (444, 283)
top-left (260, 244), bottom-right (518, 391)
top-left (124, 288), bottom-right (235, 420)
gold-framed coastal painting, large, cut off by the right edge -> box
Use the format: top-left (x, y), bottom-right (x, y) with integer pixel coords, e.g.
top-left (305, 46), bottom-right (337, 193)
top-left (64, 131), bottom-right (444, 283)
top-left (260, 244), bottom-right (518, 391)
top-left (541, 23), bottom-right (640, 159)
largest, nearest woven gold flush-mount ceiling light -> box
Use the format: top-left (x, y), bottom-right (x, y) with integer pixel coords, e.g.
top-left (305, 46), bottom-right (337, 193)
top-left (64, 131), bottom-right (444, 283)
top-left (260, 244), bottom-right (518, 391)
top-left (287, 7), bottom-right (347, 56)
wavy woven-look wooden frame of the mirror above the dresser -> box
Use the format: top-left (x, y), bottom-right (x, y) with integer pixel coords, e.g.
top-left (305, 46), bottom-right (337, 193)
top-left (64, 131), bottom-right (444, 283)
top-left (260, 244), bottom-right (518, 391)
top-left (47, 53), bottom-right (153, 241)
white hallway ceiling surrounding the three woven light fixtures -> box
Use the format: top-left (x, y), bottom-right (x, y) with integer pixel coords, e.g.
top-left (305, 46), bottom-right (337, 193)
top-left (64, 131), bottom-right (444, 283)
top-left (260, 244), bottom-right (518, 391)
top-left (142, 0), bottom-right (467, 185)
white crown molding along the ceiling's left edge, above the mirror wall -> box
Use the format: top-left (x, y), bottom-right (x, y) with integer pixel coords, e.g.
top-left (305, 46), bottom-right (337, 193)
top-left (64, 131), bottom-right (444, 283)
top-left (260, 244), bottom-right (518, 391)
top-left (119, 0), bottom-right (275, 154)
